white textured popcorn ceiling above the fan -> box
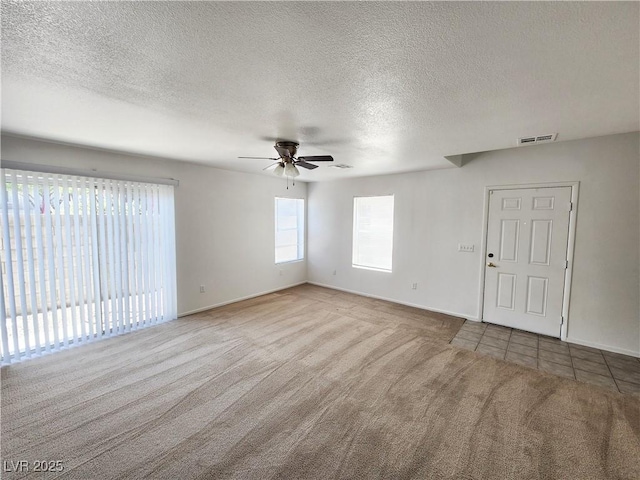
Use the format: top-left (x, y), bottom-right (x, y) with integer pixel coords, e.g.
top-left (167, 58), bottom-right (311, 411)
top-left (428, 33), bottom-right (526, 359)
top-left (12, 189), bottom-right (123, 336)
top-left (2, 0), bottom-right (640, 181)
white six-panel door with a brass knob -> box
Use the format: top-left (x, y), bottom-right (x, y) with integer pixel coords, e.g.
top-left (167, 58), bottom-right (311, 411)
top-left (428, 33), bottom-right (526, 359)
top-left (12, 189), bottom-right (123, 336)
top-left (483, 187), bottom-right (571, 337)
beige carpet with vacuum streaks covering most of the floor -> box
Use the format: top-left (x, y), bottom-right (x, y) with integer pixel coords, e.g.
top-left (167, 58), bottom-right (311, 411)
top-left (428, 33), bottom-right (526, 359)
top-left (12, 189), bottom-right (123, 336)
top-left (1, 285), bottom-right (640, 480)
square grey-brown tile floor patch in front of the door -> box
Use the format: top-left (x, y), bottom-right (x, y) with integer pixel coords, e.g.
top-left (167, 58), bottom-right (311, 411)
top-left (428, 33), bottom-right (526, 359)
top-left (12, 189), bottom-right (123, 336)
top-left (451, 321), bottom-right (640, 395)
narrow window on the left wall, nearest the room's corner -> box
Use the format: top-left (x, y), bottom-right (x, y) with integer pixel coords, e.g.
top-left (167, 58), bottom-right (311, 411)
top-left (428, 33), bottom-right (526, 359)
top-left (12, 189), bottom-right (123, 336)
top-left (275, 197), bottom-right (304, 263)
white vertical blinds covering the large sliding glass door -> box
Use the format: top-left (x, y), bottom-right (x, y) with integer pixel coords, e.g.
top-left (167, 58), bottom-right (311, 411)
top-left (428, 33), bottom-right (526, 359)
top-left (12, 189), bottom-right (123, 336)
top-left (0, 169), bottom-right (177, 364)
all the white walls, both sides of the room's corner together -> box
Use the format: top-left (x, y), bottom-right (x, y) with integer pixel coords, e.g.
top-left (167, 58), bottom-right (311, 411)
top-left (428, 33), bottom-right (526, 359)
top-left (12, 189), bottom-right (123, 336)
top-left (2, 133), bottom-right (640, 355)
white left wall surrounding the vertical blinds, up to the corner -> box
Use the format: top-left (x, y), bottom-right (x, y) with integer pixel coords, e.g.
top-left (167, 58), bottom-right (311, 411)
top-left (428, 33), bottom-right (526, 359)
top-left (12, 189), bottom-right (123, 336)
top-left (2, 135), bottom-right (307, 314)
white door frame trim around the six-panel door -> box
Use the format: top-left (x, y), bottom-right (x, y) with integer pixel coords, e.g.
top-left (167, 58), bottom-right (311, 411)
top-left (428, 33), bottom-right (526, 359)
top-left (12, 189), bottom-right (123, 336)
top-left (478, 181), bottom-right (580, 341)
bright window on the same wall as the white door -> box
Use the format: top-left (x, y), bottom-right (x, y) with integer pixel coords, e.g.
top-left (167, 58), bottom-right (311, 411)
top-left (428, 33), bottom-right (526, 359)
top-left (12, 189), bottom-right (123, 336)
top-left (353, 195), bottom-right (393, 272)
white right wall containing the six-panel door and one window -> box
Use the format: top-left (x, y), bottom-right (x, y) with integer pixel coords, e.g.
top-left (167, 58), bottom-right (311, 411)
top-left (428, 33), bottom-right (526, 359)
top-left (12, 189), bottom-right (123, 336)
top-left (308, 133), bottom-right (640, 356)
